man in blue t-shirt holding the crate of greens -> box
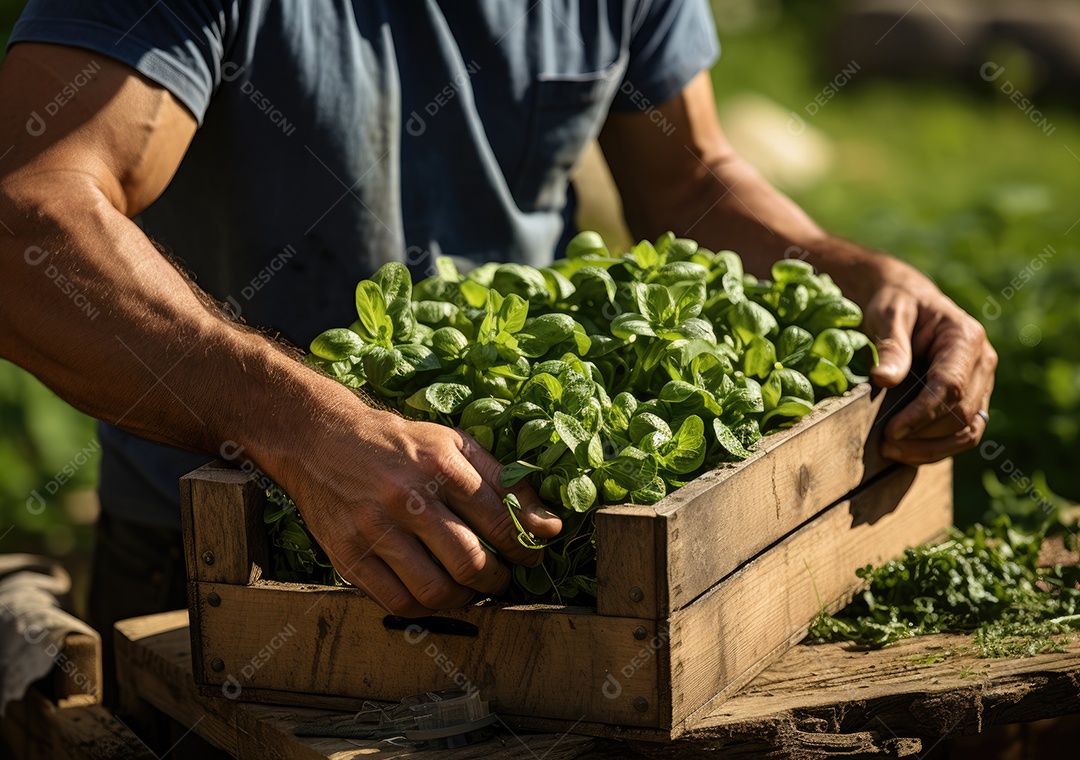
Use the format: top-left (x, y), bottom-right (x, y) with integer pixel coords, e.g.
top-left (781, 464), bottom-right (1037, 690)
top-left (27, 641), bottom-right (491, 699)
top-left (0, 0), bottom-right (997, 677)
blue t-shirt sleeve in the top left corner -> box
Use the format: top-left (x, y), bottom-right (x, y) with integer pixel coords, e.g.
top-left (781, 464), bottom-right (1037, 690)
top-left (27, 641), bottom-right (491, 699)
top-left (8, 0), bottom-right (239, 124)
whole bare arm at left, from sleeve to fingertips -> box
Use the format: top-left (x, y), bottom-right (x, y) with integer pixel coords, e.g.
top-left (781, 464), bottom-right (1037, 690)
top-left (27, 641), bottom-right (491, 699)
top-left (0, 44), bottom-right (559, 614)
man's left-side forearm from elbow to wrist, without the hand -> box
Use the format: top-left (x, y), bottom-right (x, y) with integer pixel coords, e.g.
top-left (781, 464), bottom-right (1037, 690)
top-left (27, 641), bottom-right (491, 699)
top-left (0, 174), bottom-right (362, 490)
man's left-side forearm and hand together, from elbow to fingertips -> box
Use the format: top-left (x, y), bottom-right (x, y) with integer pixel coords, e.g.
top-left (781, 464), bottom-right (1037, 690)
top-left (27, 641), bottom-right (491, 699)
top-left (0, 167), bottom-right (561, 615)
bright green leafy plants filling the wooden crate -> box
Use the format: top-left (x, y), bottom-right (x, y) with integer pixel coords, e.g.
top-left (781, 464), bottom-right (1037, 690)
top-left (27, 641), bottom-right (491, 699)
top-left (267, 232), bottom-right (877, 602)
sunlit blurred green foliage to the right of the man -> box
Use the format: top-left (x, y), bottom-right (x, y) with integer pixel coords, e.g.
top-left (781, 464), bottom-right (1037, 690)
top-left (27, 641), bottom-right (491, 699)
top-left (713, 11), bottom-right (1080, 521)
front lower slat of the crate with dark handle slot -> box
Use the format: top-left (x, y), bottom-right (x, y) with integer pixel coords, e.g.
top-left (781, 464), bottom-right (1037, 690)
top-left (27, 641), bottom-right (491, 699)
top-left (197, 583), bottom-right (671, 729)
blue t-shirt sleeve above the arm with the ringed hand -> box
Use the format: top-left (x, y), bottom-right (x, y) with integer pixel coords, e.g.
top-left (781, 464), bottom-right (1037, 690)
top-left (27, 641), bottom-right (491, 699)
top-left (611, 0), bottom-right (720, 111)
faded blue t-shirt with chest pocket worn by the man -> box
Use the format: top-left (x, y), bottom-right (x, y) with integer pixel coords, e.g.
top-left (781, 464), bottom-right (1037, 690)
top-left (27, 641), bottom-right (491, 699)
top-left (9, 0), bottom-right (718, 527)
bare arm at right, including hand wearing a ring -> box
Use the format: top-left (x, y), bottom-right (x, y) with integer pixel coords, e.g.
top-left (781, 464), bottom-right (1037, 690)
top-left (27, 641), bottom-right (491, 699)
top-left (600, 72), bottom-right (997, 464)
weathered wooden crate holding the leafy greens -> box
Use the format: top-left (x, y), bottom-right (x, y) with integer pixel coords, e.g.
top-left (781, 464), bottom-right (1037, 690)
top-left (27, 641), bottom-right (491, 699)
top-left (180, 386), bottom-right (951, 741)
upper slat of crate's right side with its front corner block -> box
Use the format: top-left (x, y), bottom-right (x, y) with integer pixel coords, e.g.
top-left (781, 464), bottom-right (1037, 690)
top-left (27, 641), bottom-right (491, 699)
top-left (596, 385), bottom-right (889, 620)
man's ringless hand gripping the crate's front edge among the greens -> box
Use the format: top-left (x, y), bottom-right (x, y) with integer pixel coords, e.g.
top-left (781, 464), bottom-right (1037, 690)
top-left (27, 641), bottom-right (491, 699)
top-left (284, 410), bottom-right (562, 616)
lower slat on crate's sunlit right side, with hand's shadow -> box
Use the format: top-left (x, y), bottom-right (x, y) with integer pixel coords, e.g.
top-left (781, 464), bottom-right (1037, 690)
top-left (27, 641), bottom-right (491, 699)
top-left (669, 460), bottom-right (953, 729)
